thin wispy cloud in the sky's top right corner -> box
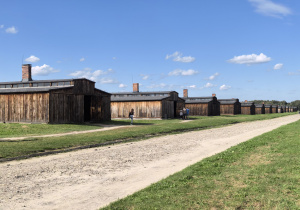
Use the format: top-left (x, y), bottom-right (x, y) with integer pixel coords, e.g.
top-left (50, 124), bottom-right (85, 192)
top-left (249, 0), bottom-right (292, 18)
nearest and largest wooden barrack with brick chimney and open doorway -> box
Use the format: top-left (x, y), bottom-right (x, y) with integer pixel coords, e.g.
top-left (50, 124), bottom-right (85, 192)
top-left (0, 64), bottom-right (110, 123)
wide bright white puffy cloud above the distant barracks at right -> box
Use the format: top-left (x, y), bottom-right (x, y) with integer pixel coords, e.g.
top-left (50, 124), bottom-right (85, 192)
top-left (228, 53), bottom-right (271, 65)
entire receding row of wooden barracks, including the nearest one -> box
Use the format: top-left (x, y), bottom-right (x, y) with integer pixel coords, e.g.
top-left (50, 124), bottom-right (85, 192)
top-left (0, 64), bottom-right (297, 123)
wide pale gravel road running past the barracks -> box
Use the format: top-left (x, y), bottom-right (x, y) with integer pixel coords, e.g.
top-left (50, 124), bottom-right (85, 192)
top-left (0, 115), bottom-right (300, 210)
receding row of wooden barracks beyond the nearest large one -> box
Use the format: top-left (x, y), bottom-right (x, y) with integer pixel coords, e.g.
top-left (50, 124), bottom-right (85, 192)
top-left (111, 83), bottom-right (296, 118)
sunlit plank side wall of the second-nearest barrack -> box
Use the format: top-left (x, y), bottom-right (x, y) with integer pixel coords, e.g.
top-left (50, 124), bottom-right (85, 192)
top-left (110, 101), bottom-right (163, 118)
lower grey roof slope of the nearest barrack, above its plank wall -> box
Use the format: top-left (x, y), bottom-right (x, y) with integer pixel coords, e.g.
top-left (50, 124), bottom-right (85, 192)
top-left (0, 86), bottom-right (73, 93)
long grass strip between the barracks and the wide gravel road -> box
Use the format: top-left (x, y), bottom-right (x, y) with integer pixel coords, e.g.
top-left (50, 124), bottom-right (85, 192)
top-left (0, 113), bottom-right (295, 160)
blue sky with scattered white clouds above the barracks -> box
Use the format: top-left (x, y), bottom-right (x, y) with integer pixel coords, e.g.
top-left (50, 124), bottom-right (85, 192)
top-left (0, 0), bottom-right (300, 102)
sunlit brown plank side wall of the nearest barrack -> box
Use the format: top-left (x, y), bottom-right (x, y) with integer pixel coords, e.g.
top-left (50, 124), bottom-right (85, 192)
top-left (0, 93), bottom-right (49, 122)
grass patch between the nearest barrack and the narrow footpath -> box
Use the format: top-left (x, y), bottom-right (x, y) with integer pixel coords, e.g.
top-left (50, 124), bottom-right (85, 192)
top-left (0, 123), bottom-right (101, 138)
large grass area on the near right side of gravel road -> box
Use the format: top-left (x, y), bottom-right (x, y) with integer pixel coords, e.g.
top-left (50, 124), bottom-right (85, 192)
top-left (104, 117), bottom-right (300, 209)
